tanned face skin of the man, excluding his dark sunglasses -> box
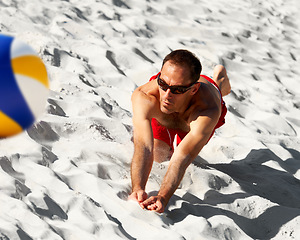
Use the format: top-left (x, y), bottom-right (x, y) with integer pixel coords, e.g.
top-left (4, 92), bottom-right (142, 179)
top-left (159, 61), bottom-right (191, 114)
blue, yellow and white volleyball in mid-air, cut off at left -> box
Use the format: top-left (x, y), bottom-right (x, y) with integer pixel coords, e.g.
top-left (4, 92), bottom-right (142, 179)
top-left (0, 34), bottom-right (49, 138)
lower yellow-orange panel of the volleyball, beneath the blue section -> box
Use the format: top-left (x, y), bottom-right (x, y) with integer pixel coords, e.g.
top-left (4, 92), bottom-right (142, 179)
top-left (0, 111), bottom-right (23, 138)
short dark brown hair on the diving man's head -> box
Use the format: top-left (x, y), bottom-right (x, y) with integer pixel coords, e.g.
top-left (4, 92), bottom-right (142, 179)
top-left (162, 49), bottom-right (202, 82)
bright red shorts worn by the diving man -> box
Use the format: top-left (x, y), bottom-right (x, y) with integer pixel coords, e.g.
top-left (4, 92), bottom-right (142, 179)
top-left (149, 73), bottom-right (227, 150)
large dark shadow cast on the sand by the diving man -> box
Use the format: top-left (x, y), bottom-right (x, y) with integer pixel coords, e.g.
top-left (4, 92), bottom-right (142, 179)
top-left (167, 148), bottom-right (300, 239)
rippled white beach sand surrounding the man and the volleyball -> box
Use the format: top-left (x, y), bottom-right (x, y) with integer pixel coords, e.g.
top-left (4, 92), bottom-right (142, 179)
top-left (0, 0), bottom-right (300, 240)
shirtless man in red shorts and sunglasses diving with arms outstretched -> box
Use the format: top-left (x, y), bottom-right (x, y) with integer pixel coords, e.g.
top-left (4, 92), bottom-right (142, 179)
top-left (129, 50), bottom-right (231, 213)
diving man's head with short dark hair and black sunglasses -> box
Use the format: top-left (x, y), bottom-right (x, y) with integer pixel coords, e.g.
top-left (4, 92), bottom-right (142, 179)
top-left (157, 50), bottom-right (202, 114)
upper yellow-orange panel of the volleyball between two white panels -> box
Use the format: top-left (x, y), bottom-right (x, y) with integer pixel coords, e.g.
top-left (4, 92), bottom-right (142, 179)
top-left (11, 55), bottom-right (49, 88)
